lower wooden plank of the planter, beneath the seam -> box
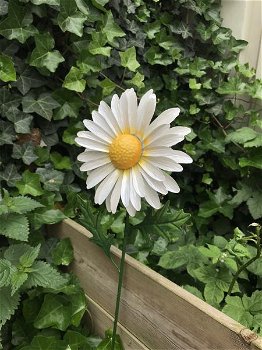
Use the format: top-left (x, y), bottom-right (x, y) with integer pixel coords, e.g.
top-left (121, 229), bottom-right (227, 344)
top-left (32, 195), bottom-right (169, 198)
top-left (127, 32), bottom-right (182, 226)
top-left (87, 296), bottom-right (149, 350)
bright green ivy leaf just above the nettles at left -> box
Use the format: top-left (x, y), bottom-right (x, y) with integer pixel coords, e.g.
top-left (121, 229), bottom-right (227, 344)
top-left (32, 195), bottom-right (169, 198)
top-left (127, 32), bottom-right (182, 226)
top-left (16, 170), bottom-right (44, 197)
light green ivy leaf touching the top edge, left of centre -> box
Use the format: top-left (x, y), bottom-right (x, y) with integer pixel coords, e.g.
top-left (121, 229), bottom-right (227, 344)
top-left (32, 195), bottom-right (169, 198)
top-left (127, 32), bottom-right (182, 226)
top-left (57, 0), bottom-right (87, 36)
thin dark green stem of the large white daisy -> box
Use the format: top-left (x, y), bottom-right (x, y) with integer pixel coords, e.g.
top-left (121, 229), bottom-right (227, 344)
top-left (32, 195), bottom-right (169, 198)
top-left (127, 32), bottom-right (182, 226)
top-left (111, 213), bottom-right (130, 350)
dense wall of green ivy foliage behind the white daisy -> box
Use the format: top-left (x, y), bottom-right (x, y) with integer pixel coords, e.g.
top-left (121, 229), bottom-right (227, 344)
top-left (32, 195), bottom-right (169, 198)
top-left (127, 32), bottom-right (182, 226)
top-left (0, 0), bottom-right (262, 342)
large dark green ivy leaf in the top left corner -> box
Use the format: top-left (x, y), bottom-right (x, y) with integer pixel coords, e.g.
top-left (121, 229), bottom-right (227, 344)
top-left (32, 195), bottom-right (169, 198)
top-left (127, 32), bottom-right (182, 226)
top-left (0, 0), bottom-right (38, 44)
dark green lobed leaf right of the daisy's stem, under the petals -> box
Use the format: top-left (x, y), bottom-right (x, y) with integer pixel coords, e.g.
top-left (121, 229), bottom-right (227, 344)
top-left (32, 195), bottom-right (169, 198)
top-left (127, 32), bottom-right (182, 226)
top-left (136, 202), bottom-right (190, 240)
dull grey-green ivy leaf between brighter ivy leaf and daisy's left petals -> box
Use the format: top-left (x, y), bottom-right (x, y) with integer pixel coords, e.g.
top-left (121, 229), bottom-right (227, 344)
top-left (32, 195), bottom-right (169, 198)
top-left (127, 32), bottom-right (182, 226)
top-left (36, 166), bottom-right (65, 192)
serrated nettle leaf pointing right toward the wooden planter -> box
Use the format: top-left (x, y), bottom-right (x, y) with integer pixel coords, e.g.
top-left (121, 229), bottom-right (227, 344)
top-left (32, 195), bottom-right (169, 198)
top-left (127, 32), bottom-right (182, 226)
top-left (26, 261), bottom-right (67, 289)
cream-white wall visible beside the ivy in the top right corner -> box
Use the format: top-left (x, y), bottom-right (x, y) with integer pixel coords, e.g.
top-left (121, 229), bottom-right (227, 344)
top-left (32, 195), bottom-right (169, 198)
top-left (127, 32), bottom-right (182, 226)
top-left (221, 0), bottom-right (262, 78)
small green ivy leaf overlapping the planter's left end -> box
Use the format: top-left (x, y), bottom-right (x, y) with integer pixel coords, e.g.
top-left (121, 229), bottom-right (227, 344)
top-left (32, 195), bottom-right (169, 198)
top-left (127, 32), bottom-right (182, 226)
top-left (52, 238), bottom-right (74, 266)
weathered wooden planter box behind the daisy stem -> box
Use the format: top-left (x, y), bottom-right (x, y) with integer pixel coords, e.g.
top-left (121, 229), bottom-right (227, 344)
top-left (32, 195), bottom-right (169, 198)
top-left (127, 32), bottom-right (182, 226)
top-left (48, 219), bottom-right (262, 350)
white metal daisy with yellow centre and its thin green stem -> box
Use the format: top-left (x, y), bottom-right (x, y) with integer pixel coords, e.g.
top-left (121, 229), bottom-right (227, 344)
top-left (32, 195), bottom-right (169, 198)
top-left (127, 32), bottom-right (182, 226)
top-left (75, 89), bottom-right (192, 349)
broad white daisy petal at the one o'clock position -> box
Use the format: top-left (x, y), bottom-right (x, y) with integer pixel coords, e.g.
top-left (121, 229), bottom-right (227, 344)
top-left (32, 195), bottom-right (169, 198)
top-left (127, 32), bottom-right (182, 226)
top-left (137, 90), bottom-right (156, 130)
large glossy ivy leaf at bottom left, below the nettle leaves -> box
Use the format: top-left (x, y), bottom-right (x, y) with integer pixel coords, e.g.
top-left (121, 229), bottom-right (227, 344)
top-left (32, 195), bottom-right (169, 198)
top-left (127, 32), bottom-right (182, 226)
top-left (34, 294), bottom-right (71, 331)
